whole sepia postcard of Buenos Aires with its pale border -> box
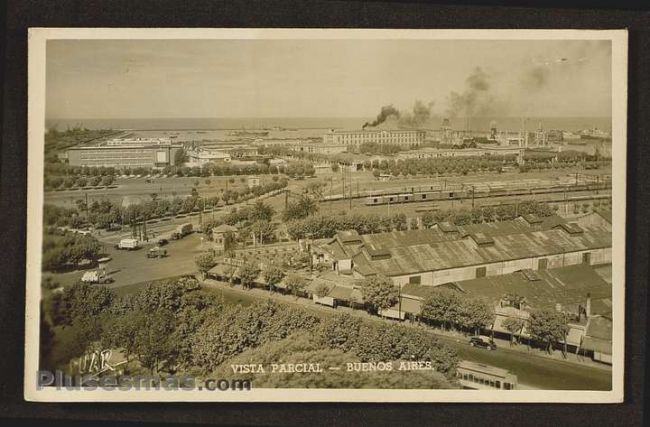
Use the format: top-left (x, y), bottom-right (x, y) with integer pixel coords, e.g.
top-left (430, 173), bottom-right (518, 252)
top-left (24, 28), bottom-right (627, 403)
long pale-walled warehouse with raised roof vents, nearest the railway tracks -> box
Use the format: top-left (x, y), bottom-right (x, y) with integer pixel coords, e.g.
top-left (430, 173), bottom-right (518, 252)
top-left (314, 220), bottom-right (612, 286)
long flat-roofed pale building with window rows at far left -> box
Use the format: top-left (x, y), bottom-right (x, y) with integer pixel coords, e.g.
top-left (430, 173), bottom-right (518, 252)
top-left (67, 142), bottom-right (182, 168)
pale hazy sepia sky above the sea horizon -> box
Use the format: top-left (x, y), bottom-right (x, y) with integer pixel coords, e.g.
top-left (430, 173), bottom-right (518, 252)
top-left (46, 40), bottom-right (612, 119)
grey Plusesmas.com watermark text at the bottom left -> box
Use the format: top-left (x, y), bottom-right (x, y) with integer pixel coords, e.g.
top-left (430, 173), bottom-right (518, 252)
top-left (36, 370), bottom-right (253, 391)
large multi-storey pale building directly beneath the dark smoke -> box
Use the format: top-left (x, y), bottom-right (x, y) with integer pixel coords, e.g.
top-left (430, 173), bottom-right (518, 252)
top-left (323, 129), bottom-right (426, 151)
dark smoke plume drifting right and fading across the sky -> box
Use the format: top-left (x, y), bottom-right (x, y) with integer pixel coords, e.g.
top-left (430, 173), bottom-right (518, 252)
top-left (364, 41), bottom-right (611, 129)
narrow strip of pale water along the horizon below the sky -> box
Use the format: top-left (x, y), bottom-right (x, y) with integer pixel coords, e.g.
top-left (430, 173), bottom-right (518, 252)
top-left (45, 117), bottom-right (612, 131)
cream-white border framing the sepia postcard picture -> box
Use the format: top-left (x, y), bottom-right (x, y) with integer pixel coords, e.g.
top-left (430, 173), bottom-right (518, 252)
top-left (24, 28), bottom-right (628, 403)
